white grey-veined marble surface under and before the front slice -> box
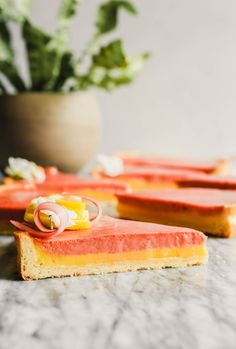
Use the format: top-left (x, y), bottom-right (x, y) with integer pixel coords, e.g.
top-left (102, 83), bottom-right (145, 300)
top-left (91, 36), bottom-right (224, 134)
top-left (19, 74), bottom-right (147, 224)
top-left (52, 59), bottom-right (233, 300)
top-left (0, 238), bottom-right (236, 349)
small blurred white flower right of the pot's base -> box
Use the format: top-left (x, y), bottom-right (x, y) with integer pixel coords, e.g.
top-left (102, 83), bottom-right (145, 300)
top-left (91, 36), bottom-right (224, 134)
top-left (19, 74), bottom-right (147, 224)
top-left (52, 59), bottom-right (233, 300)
top-left (97, 154), bottom-right (124, 177)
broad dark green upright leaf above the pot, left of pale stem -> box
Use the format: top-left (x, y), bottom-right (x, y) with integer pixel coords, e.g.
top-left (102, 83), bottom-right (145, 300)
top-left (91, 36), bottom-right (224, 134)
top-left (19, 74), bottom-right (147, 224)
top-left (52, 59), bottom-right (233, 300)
top-left (23, 20), bottom-right (57, 91)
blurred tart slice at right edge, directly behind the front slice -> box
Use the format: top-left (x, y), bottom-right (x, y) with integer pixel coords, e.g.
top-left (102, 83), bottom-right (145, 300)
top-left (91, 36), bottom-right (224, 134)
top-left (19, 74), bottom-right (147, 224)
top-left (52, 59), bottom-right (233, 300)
top-left (118, 188), bottom-right (236, 237)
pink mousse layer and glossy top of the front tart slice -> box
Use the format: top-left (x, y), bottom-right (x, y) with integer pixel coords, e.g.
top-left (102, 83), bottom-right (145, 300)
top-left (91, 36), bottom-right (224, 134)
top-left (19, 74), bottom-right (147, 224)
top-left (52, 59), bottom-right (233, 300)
top-left (31, 216), bottom-right (206, 255)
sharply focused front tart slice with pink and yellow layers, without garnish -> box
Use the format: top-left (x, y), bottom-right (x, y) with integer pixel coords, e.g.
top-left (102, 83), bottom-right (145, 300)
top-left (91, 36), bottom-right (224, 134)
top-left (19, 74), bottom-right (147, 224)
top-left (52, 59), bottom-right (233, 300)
top-left (15, 216), bottom-right (207, 280)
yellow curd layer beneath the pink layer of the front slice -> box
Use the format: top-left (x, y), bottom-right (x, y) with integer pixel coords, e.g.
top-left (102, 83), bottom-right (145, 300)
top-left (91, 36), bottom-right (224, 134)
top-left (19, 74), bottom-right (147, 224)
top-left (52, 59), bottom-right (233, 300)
top-left (35, 244), bottom-right (208, 267)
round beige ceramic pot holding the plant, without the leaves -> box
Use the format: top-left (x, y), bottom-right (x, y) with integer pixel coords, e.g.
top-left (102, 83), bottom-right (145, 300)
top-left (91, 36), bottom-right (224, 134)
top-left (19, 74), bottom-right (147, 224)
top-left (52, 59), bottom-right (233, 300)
top-left (0, 92), bottom-right (101, 172)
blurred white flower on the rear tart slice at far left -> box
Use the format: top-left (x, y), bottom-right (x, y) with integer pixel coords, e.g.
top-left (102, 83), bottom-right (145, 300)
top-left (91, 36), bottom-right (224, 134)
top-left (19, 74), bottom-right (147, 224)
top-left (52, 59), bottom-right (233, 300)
top-left (5, 157), bottom-right (46, 182)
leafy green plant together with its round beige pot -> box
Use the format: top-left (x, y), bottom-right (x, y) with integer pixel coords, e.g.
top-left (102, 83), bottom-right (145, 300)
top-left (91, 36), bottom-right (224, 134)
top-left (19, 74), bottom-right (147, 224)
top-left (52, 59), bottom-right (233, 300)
top-left (0, 0), bottom-right (148, 171)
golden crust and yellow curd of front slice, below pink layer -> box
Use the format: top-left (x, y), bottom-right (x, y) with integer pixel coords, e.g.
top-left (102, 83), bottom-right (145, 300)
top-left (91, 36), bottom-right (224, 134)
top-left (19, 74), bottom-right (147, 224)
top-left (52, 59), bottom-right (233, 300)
top-left (15, 218), bottom-right (208, 280)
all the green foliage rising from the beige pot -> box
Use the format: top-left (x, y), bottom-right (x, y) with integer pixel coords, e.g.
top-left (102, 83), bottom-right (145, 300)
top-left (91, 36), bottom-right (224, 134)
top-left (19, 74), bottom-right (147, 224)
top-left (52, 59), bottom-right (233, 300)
top-left (0, 0), bottom-right (148, 94)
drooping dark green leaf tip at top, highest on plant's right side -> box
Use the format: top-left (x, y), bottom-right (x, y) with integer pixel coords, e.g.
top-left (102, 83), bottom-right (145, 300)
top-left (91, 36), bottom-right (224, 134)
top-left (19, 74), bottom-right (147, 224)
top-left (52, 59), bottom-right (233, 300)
top-left (96, 0), bottom-right (137, 34)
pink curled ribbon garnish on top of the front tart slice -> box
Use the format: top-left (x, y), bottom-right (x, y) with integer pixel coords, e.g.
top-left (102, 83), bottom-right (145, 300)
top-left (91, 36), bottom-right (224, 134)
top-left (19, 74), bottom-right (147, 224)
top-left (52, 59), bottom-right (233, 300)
top-left (10, 195), bottom-right (102, 239)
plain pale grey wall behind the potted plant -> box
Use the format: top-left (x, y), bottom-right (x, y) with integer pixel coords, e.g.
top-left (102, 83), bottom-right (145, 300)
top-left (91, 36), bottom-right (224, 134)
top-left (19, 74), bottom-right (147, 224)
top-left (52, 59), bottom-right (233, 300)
top-left (10, 0), bottom-right (236, 157)
